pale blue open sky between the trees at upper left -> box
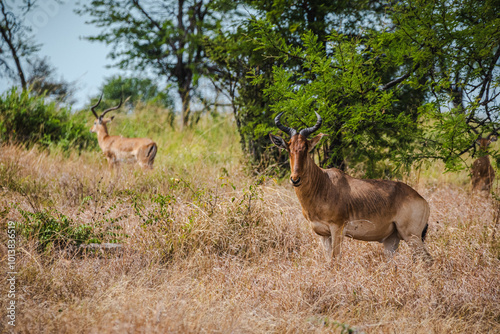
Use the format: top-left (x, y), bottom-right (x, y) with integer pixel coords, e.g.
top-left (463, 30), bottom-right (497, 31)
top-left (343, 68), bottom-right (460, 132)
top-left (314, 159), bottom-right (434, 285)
top-left (0, 0), bottom-right (119, 108)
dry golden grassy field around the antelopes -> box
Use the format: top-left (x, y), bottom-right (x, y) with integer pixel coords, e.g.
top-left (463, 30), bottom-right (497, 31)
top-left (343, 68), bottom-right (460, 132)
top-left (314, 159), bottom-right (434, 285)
top-left (0, 116), bottom-right (500, 333)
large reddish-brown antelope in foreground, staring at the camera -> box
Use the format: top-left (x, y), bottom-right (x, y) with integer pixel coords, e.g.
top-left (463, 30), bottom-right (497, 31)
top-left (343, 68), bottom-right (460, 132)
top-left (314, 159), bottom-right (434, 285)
top-left (269, 113), bottom-right (432, 263)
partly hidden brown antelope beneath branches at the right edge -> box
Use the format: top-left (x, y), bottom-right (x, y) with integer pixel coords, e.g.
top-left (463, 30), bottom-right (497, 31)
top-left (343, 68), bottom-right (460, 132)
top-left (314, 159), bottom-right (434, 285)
top-left (471, 134), bottom-right (497, 193)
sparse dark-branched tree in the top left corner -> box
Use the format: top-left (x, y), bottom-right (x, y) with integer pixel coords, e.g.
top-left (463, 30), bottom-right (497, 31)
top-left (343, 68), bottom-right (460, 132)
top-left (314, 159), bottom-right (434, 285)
top-left (0, 0), bottom-right (40, 90)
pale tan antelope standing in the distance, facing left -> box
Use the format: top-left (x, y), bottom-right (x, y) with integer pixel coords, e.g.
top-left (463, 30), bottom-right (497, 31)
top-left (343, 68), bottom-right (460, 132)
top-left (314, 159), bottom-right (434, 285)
top-left (90, 95), bottom-right (157, 168)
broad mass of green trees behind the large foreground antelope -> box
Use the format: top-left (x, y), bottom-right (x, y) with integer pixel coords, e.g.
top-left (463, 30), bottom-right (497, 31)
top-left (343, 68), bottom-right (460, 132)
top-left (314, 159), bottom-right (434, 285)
top-left (209, 0), bottom-right (500, 177)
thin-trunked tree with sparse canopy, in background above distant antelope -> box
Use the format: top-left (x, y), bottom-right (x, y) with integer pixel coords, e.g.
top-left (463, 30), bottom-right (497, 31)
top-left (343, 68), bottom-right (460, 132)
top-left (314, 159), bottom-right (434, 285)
top-left (77, 0), bottom-right (230, 126)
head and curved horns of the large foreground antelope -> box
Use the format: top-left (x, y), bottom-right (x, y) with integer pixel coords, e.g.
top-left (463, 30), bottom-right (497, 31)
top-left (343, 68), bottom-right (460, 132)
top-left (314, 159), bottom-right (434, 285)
top-left (269, 112), bottom-right (326, 187)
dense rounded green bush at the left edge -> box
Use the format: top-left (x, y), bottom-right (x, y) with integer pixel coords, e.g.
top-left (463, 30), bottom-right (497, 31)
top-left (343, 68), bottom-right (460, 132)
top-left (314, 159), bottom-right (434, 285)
top-left (0, 88), bottom-right (96, 151)
